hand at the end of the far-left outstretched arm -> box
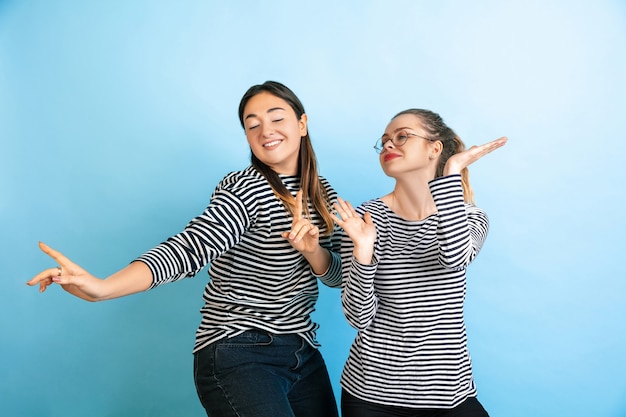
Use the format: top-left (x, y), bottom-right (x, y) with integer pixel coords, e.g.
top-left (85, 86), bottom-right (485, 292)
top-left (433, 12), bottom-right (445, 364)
top-left (26, 242), bottom-right (102, 301)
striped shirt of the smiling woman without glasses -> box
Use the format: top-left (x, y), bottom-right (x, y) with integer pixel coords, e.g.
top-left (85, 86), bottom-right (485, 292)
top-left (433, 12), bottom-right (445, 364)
top-left (137, 166), bottom-right (341, 352)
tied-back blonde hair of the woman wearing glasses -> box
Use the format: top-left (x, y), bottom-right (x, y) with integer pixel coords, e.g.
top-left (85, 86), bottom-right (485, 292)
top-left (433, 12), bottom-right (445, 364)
top-left (392, 109), bottom-right (474, 204)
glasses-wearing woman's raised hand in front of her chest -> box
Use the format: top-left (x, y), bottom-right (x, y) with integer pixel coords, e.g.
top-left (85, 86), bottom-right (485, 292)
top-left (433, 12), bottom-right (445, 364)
top-left (332, 198), bottom-right (376, 264)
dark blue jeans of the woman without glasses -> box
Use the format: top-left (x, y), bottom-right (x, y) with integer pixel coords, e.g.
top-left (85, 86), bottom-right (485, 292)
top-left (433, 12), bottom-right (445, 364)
top-left (194, 330), bottom-right (338, 417)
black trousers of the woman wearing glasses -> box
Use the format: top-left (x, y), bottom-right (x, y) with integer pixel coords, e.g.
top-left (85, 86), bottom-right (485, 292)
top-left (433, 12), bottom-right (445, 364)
top-left (341, 390), bottom-right (489, 417)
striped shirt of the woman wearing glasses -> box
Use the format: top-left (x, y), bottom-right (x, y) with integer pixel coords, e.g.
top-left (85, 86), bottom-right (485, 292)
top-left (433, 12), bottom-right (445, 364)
top-left (341, 175), bottom-right (488, 408)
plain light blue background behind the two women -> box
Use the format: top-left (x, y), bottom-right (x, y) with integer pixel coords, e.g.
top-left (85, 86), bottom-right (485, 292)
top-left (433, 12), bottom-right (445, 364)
top-left (0, 0), bottom-right (626, 417)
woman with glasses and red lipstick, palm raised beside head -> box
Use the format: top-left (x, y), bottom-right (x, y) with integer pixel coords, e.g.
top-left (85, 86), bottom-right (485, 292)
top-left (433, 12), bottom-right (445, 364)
top-left (334, 109), bottom-right (507, 417)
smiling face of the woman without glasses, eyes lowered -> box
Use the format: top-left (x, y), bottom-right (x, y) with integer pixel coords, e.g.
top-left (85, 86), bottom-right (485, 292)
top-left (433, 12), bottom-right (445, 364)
top-left (243, 92), bottom-right (307, 175)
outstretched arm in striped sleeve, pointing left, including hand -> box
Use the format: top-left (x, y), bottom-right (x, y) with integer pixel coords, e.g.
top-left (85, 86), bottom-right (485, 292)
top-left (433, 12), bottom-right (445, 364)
top-left (27, 176), bottom-right (249, 301)
